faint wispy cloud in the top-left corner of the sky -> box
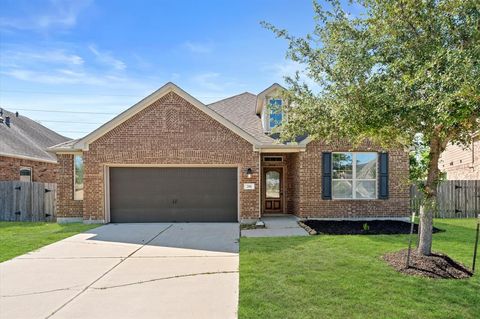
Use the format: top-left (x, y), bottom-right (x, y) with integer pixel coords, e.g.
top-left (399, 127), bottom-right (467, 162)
top-left (0, 0), bottom-right (92, 32)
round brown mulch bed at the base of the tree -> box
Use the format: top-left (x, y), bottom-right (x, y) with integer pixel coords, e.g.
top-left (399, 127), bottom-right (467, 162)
top-left (383, 249), bottom-right (473, 279)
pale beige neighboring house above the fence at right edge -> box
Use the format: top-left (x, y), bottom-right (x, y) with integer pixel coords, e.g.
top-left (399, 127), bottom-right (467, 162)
top-left (439, 135), bottom-right (480, 180)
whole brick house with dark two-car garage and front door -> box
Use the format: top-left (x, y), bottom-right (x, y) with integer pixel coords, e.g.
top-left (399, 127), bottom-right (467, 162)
top-left (51, 83), bottom-right (409, 223)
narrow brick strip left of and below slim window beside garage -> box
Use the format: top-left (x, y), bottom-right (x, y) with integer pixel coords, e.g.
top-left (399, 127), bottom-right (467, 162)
top-left (57, 154), bottom-right (83, 218)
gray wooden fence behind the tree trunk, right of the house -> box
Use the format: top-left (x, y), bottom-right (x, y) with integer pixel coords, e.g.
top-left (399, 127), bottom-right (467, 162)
top-left (410, 180), bottom-right (480, 218)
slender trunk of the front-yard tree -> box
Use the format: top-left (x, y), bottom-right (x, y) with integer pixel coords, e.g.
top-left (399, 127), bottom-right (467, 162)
top-left (418, 138), bottom-right (446, 256)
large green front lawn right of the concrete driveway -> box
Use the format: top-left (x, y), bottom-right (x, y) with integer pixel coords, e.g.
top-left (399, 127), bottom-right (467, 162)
top-left (239, 219), bottom-right (480, 319)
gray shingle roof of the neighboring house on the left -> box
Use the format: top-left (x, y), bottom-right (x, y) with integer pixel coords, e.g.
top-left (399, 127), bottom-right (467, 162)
top-left (0, 110), bottom-right (69, 161)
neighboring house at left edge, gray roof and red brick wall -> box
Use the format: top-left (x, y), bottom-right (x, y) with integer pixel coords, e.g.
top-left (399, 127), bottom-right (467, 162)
top-left (0, 109), bottom-right (68, 183)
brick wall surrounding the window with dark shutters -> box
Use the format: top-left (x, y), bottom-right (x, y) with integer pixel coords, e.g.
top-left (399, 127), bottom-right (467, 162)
top-left (296, 141), bottom-right (410, 218)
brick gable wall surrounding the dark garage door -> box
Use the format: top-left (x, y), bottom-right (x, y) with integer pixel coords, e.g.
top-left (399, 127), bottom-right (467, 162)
top-left (77, 93), bottom-right (259, 220)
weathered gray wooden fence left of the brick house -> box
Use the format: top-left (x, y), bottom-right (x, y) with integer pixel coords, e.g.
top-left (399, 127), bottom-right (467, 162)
top-left (0, 181), bottom-right (57, 222)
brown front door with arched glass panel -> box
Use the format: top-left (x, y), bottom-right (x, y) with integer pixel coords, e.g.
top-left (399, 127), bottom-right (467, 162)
top-left (263, 167), bottom-right (283, 213)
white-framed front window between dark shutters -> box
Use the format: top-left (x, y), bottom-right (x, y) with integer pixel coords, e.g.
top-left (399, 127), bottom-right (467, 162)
top-left (332, 152), bottom-right (377, 199)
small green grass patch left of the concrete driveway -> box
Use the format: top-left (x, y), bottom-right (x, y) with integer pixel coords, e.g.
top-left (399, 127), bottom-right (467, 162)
top-left (0, 222), bottom-right (98, 262)
